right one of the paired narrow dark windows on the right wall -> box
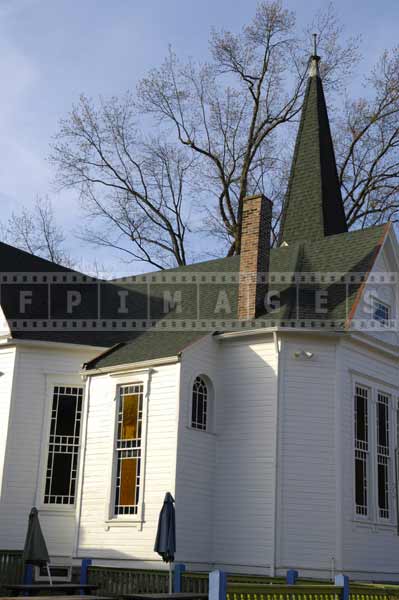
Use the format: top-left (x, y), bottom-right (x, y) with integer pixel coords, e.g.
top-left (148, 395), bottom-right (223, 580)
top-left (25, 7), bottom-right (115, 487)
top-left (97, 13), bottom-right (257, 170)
top-left (377, 392), bottom-right (390, 519)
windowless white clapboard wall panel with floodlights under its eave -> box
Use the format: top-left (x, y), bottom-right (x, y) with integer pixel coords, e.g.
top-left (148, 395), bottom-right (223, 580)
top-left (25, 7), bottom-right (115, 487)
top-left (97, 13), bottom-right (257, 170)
top-left (277, 336), bottom-right (336, 576)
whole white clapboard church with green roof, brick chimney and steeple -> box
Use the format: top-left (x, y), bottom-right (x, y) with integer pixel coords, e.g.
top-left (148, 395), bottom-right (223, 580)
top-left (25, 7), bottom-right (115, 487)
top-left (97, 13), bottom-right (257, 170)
top-left (0, 52), bottom-right (399, 581)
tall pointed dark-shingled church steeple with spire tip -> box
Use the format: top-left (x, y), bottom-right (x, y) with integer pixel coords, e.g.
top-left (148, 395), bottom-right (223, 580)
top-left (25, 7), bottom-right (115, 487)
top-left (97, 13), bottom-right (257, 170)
top-left (279, 42), bottom-right (348, 244)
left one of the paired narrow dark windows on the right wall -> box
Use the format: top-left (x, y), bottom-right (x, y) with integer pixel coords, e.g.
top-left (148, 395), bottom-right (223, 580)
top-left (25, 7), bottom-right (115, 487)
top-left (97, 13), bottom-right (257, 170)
top-left (355, 385), bottom-right (369, 516)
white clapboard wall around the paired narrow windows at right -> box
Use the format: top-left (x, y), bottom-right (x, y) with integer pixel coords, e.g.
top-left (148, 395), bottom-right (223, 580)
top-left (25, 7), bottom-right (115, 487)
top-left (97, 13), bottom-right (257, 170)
top-left (339, 343), bottom-right (399, 580)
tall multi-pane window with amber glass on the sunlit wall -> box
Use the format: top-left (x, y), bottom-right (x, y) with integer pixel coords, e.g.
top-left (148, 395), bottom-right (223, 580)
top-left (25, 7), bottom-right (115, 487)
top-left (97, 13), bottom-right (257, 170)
top-left (115, 383), bottom-right (143, 515)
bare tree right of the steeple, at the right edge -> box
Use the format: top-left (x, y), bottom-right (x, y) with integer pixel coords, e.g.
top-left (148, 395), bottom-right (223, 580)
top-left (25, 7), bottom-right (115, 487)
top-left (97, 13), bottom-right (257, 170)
top-left (336, 47), bottom-right (399, 227)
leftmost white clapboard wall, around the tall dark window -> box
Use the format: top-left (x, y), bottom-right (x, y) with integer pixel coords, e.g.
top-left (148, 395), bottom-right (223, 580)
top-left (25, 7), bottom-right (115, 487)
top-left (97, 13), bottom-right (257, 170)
top-left (0, 345), bottom-right (96, 557)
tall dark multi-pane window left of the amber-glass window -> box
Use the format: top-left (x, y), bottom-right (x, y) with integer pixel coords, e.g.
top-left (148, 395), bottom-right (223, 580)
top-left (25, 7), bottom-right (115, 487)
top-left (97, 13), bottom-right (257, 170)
top-left (44, 386), bottom-right (83, 505)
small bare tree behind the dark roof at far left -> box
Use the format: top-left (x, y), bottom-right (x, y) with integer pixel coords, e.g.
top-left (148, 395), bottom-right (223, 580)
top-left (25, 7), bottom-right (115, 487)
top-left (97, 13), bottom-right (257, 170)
top-left (1, 196), bottom-right (73, 267)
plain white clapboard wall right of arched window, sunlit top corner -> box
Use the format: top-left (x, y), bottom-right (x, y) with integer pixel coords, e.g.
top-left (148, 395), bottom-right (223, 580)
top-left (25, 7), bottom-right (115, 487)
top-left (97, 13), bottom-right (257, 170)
top-left (213, 336), bottom-right (277, 572)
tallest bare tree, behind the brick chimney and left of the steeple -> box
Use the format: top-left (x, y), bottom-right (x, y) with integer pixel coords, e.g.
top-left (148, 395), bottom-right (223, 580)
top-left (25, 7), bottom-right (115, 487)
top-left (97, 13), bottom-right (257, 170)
top-left (138, 1), bottom-right (356, 254)
